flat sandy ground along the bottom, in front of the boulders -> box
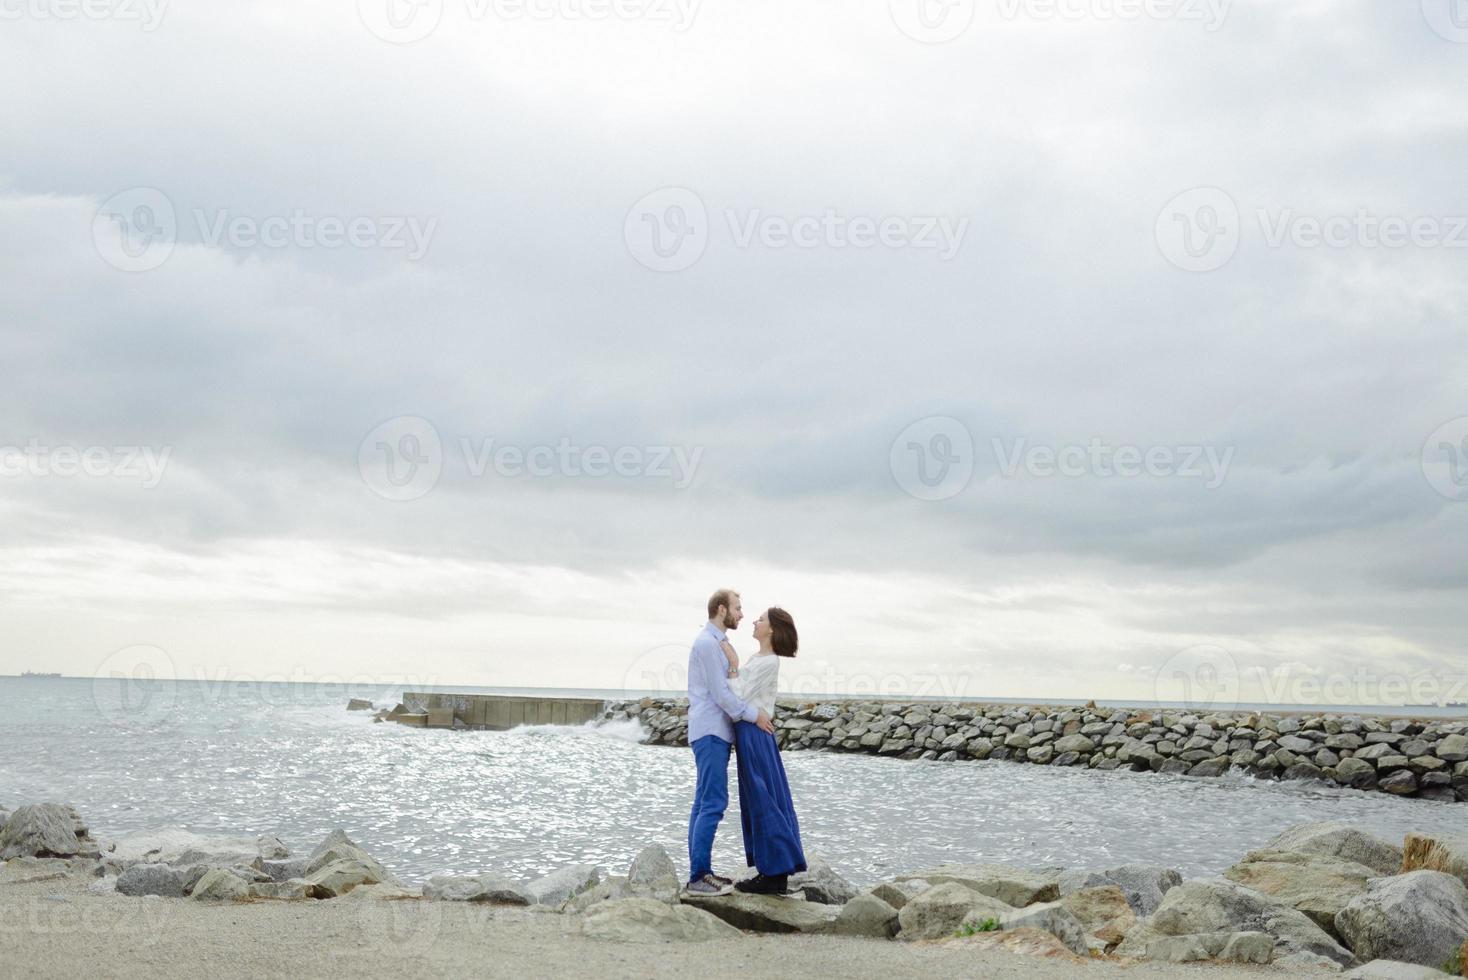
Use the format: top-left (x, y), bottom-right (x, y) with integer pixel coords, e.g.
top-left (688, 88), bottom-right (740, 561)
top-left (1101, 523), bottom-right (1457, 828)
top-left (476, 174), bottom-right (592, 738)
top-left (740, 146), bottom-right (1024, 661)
top-left (0, 876), bottom-right (1287, 980)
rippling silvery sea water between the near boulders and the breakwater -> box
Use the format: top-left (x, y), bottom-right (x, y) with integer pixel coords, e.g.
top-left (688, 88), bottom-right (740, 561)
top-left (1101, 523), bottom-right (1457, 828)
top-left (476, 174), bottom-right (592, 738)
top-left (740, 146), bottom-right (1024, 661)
top-left (0, 679), bottom-right (1468, 883)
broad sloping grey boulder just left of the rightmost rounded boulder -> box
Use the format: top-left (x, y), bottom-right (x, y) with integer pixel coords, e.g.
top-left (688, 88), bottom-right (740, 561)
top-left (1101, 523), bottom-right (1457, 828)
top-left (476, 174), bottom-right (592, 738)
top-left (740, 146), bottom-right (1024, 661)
top-left (1145, 877), bottom-right (1352, 965)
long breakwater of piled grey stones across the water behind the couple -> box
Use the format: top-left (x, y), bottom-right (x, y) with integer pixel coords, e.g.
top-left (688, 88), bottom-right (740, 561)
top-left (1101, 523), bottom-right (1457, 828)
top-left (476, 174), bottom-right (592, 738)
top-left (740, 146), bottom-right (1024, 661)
top-left (603, 698), bottom-right (1468, 802)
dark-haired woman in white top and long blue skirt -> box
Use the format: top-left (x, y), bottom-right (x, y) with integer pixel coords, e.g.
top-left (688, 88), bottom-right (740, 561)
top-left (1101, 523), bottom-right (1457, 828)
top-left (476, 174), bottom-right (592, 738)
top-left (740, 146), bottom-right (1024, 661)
top-left (724, 607), bottom-right (806, 895)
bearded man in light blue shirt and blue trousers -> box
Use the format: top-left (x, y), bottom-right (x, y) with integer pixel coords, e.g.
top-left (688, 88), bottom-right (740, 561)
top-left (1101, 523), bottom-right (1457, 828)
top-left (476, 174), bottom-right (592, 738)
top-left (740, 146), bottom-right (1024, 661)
top-left (687, 588), bottom-right (775, 896)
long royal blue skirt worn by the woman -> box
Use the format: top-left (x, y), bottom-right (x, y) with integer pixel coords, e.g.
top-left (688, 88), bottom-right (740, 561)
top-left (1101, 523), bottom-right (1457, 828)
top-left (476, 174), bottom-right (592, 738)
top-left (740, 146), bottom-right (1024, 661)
top-left (734, 722), bottom-right (806, 874)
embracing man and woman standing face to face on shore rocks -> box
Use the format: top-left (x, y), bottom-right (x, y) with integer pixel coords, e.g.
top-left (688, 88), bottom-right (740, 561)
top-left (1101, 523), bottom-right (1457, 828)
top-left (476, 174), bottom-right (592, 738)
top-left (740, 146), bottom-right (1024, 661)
top-left (686, 588), bottom-right (806, 896)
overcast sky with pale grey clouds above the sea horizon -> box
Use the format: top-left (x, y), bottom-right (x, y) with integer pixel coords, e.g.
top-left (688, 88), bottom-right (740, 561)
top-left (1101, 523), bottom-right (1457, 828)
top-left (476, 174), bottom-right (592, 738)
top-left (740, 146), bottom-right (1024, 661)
top-left (0, 0), bottom-right (1468, 703)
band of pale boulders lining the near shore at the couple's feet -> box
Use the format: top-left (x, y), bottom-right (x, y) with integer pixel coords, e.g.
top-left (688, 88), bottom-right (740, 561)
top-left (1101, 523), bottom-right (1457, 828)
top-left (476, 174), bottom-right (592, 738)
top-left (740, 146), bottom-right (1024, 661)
top-left (0, 802), bottom-right (1468, 980)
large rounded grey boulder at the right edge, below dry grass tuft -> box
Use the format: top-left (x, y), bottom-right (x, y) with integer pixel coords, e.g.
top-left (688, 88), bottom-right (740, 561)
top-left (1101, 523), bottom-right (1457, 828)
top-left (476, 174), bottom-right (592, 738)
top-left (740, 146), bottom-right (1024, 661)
top-left (1336, 870), bottom-right (1468, 967)
